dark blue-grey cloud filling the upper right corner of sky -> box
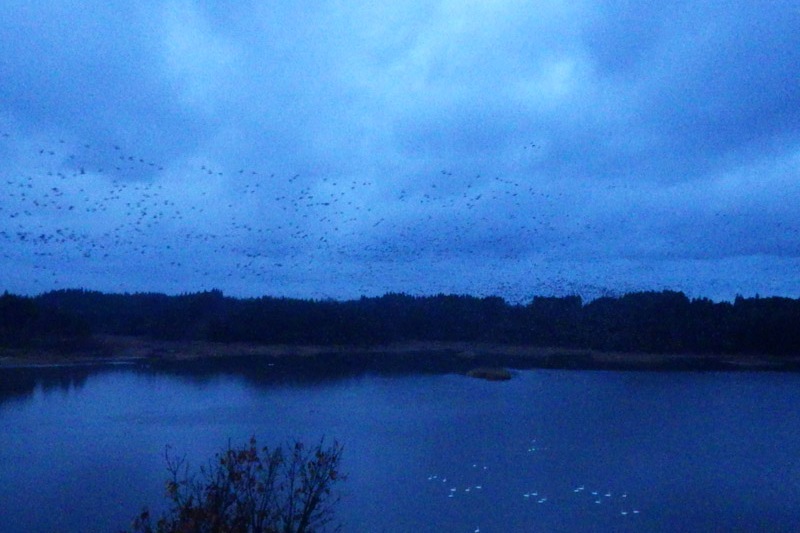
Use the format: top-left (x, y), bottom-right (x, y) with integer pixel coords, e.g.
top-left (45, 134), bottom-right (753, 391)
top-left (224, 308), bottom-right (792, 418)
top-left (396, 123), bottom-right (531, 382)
top-left (587, 2), bottom-right (800, 179)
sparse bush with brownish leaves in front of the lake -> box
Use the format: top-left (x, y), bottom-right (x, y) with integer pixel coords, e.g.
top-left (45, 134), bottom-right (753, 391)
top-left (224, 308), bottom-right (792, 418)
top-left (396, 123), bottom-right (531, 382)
top-left (128, 437), bottom-right (344, 533)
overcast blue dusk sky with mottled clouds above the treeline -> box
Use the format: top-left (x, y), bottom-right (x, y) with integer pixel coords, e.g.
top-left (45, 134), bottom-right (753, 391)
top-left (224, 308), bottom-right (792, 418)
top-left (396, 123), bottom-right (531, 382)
top-left (0, 0), bottom-right (800, 301)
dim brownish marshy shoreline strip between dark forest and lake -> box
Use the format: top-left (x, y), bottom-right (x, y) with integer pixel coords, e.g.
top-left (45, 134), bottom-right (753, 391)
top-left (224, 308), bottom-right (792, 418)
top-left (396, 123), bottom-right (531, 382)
top-left (0, 337), bottom-right (800, 372)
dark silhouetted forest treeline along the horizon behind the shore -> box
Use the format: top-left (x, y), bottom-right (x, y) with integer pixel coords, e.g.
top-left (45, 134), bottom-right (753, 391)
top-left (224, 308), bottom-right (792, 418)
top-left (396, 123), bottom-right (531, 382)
top-left (0, 290), bottom-right (800, 355)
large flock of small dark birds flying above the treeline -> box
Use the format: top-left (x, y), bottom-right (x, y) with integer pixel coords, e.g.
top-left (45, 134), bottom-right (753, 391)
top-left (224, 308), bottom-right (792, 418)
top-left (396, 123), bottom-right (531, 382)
top-left (0, 125), bottom-right (780, 297)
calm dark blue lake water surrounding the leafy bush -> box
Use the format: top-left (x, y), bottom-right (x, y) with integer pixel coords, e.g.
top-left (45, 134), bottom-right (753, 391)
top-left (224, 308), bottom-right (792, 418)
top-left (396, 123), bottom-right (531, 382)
top-left (0, 364), bottom-right (800, 533)
